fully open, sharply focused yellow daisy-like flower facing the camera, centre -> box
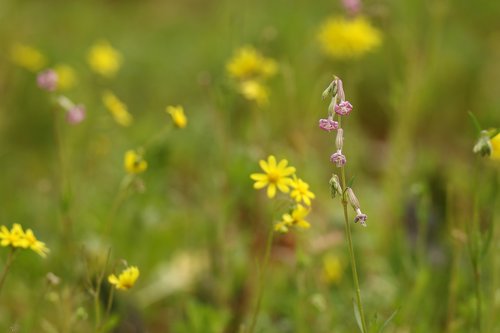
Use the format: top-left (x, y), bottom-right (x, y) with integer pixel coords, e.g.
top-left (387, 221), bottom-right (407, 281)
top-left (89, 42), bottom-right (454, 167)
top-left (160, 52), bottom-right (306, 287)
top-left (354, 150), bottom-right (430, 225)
top-left (250, 155), bottom-right (295, 198)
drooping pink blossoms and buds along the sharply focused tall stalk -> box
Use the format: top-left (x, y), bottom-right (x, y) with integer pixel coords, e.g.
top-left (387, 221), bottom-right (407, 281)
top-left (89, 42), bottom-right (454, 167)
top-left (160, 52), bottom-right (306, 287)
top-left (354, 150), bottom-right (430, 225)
top-left (319, 76), bottom-right (368, 226)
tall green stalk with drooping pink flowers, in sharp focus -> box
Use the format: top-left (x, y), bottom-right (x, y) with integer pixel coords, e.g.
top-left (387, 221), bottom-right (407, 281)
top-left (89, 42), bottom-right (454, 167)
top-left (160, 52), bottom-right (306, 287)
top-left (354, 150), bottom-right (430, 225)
top-left (319, 76), bottom-right (368, 333)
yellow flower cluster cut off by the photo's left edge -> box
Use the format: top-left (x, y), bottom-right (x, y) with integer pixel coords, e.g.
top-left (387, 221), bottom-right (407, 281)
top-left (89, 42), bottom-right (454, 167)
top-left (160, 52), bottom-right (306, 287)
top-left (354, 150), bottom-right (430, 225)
top-left (0, 223), bottom-right (49, 257)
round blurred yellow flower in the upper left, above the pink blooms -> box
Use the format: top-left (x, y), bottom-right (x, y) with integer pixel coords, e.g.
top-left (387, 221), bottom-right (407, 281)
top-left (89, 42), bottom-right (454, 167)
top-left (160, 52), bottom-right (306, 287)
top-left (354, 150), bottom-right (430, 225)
top-left (87, 41), bottom-right (122, 78)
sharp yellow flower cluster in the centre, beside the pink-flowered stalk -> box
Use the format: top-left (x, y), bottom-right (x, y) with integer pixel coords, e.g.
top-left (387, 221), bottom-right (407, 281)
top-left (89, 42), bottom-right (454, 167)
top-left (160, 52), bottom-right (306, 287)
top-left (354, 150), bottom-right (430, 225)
top-left (250, 155), bottom-right (315, 232)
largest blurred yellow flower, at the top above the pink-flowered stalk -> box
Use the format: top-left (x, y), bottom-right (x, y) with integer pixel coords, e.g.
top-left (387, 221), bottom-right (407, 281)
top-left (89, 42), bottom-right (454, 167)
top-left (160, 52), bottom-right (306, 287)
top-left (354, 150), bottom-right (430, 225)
top-left (317, 16), bottom-right (382, 59)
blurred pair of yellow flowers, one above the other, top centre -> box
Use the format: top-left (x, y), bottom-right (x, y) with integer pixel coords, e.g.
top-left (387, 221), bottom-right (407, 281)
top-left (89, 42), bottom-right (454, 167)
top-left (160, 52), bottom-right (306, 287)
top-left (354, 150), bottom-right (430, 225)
top-left (226, 46), bottom-right (278, 105)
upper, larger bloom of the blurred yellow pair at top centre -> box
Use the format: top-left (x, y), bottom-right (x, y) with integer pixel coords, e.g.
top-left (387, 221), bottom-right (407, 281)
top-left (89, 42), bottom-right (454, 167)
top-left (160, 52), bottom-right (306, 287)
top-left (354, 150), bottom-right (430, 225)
top-left (226, 46), bottom-right (278, 80)
